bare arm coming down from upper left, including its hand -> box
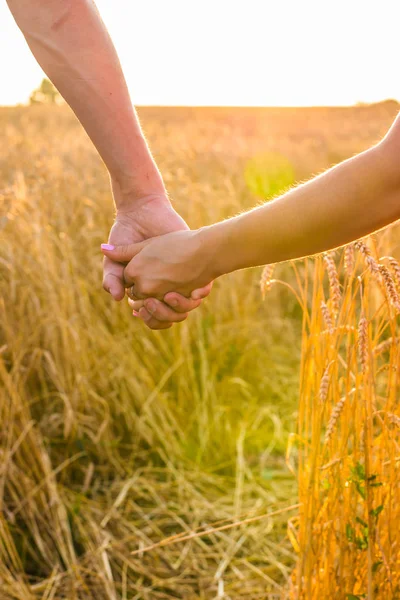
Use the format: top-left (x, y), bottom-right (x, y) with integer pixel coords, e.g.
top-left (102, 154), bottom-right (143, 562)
top-left (7, 0), bottom-right (211, 329)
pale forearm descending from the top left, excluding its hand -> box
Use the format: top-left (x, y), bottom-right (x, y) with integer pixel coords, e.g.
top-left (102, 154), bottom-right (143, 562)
top-left (8, 0), bottom-right (164, 199)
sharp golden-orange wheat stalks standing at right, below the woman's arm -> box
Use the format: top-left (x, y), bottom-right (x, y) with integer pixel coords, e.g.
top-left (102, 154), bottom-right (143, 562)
top-left (289, 232), bottom-right (400, 600)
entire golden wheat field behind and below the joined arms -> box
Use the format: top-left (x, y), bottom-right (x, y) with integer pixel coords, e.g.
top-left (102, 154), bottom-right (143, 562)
top-left (0, 102), bottom-right (400, 600)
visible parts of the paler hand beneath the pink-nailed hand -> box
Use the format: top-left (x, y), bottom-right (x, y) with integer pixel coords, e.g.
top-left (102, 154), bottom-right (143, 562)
top-left (103, 190), bottom-right (211, 329)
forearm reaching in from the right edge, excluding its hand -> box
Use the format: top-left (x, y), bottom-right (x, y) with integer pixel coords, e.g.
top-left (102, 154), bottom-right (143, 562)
top-left (206, 139), bottom-right (400, 275)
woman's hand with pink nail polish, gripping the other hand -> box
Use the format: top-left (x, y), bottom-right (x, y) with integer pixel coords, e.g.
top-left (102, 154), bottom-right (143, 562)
top-left (102, 229), bottom-right (214, 300)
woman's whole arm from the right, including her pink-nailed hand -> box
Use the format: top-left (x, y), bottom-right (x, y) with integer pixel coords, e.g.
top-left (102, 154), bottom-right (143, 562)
top-left (103, 126), bottom-right (400, 309)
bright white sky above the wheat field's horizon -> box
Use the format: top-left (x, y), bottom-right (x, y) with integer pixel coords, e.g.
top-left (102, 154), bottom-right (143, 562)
top-left (0, 0), bottom-right (400, 106)
